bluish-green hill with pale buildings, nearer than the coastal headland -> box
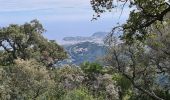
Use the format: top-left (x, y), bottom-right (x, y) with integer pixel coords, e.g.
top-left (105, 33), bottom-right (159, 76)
top-left (65, 42), bottom-right (106, 64)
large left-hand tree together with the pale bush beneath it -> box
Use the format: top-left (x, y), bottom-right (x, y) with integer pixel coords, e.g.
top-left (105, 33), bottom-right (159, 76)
top-left (0, 20), bottom-right (67, 100)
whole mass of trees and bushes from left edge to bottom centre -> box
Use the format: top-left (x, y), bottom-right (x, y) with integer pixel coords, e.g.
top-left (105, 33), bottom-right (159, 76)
top-left (0, 20), bottom-right (118, 100)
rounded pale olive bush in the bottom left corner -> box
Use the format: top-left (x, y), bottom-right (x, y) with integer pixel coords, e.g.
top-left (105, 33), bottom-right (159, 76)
top-left (0, 59), bottom-right (54, 100)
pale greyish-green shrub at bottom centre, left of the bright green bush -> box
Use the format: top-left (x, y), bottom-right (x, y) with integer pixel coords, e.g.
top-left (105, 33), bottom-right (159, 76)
top-left (47, 66), bottom-right (84, 99)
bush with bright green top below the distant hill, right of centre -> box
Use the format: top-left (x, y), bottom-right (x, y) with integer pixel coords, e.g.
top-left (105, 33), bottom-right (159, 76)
top-left (80, 62), bottom-right (119, 100)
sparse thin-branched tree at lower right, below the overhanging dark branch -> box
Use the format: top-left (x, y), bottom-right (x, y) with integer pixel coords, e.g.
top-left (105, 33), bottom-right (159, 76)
top-left (105, 37), bottom-right (169, 100)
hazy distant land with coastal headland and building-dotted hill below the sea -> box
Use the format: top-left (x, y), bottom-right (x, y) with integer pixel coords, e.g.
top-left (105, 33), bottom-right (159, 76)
top-left (56, 32), bottom-right (107, 65)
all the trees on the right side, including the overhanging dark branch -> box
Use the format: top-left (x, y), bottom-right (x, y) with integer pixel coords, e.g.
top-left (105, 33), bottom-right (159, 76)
top-left (91, 0), bottom-right (170, 100)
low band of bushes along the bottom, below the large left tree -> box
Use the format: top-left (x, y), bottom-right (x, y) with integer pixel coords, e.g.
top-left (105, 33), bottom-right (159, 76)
top-left (0, 59), bottom-right (119, 100)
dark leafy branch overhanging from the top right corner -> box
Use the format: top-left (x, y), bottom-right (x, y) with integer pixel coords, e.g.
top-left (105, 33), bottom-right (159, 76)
top-left (91, 0), bottom-right (170, 43)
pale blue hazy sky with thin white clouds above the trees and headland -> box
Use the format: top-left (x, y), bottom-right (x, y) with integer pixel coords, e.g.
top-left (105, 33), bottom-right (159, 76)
top-left (0, 0), bottom-right (129, 40)
